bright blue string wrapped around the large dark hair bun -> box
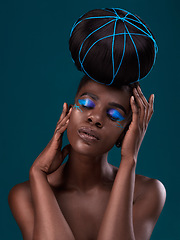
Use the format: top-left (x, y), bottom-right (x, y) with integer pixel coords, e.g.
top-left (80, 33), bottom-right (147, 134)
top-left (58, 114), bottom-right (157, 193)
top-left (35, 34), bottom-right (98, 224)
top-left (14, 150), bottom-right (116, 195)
top-left (70, 8), bottom-right (158, 85)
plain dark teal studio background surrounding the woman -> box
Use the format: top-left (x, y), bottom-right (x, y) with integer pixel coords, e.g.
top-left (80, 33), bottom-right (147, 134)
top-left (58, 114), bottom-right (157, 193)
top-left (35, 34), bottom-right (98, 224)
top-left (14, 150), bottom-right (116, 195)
top-left (0, 0), bottom-right (180, 240)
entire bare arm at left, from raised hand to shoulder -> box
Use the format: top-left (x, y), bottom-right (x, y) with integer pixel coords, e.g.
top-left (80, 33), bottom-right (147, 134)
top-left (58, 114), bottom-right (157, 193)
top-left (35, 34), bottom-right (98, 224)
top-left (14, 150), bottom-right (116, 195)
top-left (8, 104), bottom-right (74, 240)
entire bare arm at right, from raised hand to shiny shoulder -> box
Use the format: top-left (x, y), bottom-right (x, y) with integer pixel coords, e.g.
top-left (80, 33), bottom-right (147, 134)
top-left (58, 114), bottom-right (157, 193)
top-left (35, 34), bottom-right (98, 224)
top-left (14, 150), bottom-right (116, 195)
top-left (98, 86), bottom-right (166, 240)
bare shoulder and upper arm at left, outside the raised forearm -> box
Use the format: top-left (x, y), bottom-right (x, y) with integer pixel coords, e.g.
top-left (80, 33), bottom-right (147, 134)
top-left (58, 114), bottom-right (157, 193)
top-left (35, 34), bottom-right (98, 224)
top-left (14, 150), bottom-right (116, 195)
top-left (8, 181), bottom-right (34, 240)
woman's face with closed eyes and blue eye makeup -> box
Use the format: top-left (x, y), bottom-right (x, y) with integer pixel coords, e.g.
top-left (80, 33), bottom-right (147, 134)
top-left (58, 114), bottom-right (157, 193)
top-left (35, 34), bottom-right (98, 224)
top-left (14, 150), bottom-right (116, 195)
top-left (67, 81), bottom-right (131, 156)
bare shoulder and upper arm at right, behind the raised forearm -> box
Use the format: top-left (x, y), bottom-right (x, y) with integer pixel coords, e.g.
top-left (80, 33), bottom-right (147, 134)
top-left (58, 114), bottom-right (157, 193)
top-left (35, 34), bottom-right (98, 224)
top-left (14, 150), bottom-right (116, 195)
top-left (133, 175), bottom-right (166, 239)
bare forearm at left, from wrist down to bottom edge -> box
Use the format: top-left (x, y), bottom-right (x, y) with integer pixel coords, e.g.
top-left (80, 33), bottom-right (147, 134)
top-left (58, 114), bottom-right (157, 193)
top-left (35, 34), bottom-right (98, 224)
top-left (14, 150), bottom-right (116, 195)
top-left (29, 169), bottom-right (74, 240)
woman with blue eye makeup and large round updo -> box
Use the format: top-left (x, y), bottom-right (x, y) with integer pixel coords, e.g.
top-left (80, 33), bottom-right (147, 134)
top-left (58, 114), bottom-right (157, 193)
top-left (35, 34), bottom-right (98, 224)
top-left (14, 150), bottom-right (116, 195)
top-left (9, 9), bottom-right (166, 240)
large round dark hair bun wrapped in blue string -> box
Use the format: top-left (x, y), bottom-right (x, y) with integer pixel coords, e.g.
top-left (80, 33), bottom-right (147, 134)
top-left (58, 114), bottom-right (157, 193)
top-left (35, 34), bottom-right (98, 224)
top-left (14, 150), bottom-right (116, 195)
top-left (69, 8), bottom-right (157, 86)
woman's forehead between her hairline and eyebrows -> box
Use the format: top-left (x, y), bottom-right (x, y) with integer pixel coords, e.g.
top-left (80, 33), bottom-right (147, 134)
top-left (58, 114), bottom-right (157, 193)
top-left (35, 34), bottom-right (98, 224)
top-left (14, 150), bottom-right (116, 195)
top-left (77, 80), bottom-right (131, 112)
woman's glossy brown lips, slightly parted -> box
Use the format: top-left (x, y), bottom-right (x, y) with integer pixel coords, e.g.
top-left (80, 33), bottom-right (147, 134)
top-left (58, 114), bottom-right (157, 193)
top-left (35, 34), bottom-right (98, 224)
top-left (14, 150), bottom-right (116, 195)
top-left (78, 127), bottom-right (100, 141)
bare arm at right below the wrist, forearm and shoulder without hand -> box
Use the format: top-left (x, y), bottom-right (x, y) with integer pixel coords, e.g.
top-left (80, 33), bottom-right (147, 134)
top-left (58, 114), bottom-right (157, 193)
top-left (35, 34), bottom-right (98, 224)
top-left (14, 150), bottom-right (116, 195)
top-left (97, 158), bottom-right (166, 240)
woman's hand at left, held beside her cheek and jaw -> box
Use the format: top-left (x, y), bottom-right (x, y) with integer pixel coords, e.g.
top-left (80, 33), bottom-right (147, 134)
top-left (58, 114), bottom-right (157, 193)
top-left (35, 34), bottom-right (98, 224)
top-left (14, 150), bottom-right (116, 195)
top-left (31, 103), bottom-right (72, 174)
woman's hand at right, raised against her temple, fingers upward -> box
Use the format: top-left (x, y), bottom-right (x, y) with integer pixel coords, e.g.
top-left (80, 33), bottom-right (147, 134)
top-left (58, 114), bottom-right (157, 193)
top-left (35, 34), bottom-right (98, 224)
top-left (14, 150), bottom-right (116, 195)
top-left (121, 86), bottom-right (154, 164)
